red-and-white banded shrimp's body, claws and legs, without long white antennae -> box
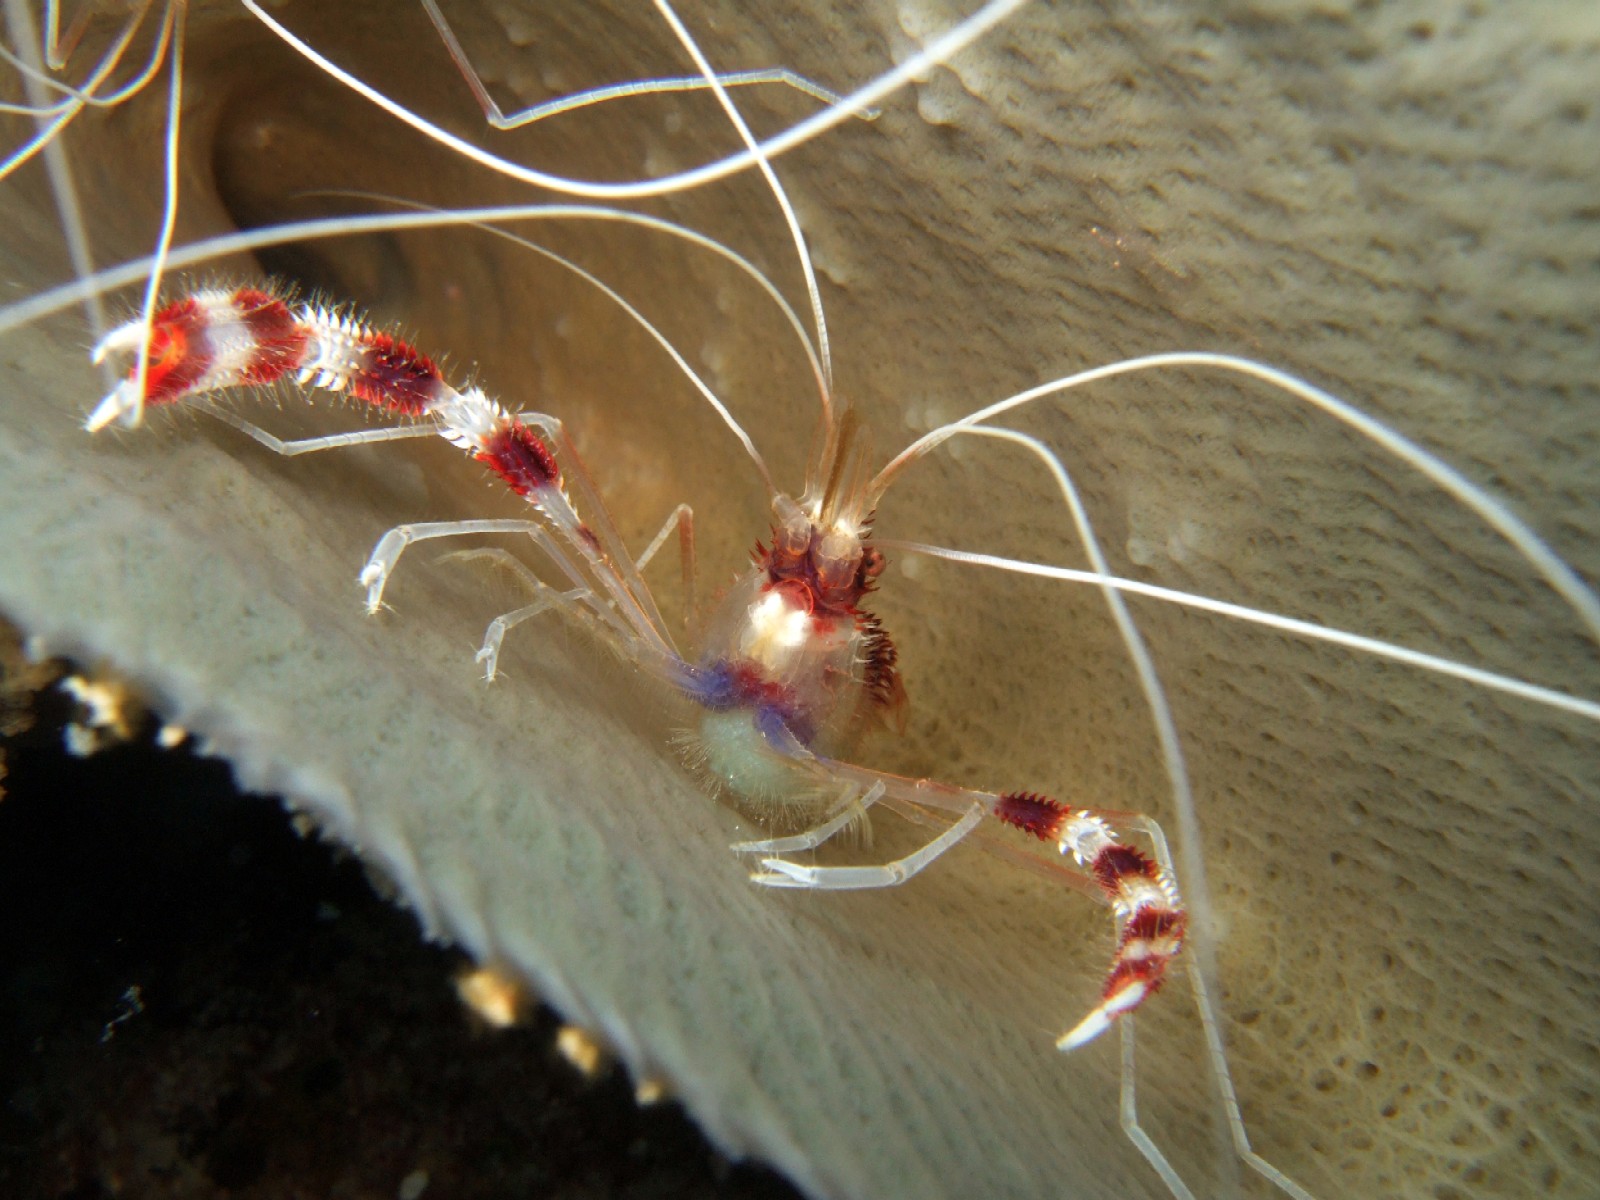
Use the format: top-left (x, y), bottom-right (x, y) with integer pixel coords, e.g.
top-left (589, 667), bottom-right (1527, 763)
top-left (86, 276), bottom-right (1187, 1050)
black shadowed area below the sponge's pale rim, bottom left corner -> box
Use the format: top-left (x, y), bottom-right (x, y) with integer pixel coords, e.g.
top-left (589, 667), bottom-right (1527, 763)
top-left (0, 693), bottom-right (794, 1200)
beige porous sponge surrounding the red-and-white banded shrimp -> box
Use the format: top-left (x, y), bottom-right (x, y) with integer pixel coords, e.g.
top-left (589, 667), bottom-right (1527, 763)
top-left (0, 3), bottom-right (1600, 1197)
